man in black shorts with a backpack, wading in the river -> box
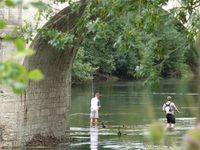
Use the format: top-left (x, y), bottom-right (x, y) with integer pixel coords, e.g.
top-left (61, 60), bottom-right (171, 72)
top-left (162, 96), bottom-right (179, 129)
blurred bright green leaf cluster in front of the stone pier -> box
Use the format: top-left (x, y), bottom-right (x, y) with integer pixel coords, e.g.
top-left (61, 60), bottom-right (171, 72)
top-left (0, 37), bottom-right (43, 94)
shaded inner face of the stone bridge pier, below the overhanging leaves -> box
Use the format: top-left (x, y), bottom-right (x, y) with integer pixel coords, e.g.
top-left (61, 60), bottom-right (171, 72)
top-left (20, 36), bottom-right (71, 145)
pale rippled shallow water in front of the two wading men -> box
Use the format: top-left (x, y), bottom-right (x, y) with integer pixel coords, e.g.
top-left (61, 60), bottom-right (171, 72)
top-left (70, 118), bottom-right (195, 150)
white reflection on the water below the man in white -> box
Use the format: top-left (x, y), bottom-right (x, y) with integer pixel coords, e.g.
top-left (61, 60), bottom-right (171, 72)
top-left (90, 127), bottom-right (99, 150)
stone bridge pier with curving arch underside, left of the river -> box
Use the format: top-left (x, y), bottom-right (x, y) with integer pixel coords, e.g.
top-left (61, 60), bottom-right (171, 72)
top-left (0, 1), bottom-right (84, 147)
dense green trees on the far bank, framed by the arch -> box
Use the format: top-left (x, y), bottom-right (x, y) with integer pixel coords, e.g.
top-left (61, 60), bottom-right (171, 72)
top-left (72, 5), bottom-right (198, 83)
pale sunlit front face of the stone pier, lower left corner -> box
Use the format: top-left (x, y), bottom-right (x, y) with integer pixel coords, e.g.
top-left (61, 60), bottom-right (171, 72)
top-left (0, 87), bottom-right (20, 147)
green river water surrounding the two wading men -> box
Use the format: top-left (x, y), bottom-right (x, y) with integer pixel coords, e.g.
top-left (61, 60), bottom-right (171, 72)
top-left (69, 80), bottom-right (198, 150)
